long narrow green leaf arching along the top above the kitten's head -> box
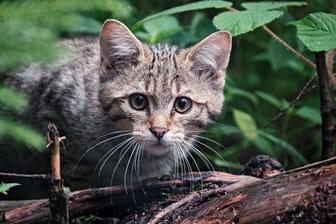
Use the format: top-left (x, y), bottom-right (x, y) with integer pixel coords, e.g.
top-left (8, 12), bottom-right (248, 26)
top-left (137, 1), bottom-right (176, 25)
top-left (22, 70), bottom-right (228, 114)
top-left (133, 0), bottom-right (232, 30)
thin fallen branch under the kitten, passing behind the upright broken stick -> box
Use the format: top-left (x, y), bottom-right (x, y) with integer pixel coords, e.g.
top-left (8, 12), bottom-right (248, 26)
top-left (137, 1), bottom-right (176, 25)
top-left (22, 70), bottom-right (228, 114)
top-left (3, 172), bottom-right (259, 224)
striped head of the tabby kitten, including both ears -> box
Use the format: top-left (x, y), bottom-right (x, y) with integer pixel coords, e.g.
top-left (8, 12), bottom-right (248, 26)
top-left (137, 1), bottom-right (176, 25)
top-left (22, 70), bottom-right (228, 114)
top-left (100, 20), bottom-right (231, 156)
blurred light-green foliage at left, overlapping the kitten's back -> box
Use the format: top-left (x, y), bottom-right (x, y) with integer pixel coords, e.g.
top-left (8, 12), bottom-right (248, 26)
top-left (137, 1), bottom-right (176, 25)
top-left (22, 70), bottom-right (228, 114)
top-left (0, 0), bottom-right (132, 150)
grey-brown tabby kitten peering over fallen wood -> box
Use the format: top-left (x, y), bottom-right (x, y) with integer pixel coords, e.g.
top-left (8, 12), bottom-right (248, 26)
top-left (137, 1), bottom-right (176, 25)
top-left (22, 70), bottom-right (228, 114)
top-left (0, 20), bottom-right (231, 189)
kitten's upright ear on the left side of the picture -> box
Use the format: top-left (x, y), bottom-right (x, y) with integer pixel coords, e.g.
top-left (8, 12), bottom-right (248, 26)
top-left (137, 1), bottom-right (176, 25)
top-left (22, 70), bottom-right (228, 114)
top-left (100, 19), bottom-right (149, 72)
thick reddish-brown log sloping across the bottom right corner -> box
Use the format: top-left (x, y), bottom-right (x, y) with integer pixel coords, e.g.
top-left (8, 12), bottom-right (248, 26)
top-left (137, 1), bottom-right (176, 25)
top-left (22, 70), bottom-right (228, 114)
top-left (178, 157), bottom-right (336, 224)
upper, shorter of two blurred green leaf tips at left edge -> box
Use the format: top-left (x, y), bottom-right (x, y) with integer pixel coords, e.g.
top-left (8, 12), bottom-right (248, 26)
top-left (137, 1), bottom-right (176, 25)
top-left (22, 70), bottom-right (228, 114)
top-left (0, 86), bottom-right (28, 113)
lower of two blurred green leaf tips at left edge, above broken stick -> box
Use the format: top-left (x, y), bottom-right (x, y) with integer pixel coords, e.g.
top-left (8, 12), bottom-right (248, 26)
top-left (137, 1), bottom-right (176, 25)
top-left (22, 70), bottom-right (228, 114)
top-left (0, 117), bottom-right (46, 151)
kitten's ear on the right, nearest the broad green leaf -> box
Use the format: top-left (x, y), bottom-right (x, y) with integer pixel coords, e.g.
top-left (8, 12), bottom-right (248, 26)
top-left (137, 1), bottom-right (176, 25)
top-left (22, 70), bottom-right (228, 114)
top-left (186, 31), bottom-right (232, 87)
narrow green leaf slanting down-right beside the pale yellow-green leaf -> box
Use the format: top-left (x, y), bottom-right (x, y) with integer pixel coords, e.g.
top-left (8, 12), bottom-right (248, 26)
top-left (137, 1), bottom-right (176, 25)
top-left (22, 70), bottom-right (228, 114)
top-left (258, 130), bottom-right (308, 164)
